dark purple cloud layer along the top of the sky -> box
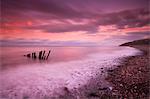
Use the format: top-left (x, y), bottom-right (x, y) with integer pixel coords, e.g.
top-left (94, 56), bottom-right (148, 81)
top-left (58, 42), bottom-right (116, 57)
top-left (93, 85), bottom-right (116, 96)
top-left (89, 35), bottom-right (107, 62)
top-left (1, 0), bottom-right (148, 18)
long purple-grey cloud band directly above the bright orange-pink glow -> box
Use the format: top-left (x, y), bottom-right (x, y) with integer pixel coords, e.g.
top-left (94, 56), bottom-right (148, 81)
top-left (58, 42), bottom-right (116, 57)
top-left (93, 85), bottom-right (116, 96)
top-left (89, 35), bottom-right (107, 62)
top-left (24, 9), bottom-right (150, 33)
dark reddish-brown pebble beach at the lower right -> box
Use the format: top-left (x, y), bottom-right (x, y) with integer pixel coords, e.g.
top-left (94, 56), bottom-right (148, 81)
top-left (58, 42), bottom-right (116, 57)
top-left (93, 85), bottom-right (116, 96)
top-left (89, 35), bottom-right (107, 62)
top-left (106, 45), bottom-right (150, 99)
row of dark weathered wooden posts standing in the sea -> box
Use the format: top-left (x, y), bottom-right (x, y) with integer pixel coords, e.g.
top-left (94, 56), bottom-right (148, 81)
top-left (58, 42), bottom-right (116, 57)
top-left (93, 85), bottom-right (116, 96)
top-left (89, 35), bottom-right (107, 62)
top-left (24, 50), bottom-right (51, 60)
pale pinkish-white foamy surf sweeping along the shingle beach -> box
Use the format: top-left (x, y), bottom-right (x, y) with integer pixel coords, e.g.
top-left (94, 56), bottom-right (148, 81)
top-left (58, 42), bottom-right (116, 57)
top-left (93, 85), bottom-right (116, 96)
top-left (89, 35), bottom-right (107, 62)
top-left (0, 47), bottom-right (139, 99)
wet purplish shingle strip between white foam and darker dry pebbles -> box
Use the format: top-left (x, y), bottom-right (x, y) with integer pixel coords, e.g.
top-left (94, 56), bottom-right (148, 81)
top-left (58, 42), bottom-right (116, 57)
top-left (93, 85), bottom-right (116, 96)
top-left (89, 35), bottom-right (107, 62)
top-left (57, 46), bottom-right (144, 99)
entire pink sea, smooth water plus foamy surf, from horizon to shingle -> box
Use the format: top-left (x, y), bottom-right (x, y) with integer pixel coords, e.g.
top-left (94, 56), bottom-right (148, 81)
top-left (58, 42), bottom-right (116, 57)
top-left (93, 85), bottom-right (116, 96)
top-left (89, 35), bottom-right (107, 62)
top-left (0, 47), bottom-right (140, 99)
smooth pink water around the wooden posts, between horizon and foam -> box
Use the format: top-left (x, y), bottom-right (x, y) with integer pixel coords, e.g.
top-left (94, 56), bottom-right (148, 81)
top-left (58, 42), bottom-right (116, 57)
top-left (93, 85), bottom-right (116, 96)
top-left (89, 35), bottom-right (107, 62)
top-left (0, 47), bottom-right (134, 69)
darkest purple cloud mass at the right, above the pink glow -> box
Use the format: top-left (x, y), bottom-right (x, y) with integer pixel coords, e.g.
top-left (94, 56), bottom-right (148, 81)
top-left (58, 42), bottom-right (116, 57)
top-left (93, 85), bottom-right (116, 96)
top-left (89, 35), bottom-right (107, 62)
top-left (97, 9), bottom-right (150, 29)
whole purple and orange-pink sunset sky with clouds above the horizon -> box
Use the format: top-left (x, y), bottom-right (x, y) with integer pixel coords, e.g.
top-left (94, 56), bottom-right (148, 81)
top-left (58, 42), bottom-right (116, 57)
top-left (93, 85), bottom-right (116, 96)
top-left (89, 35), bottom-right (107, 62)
top-left (0, 0), bottom-right (150, 46)
